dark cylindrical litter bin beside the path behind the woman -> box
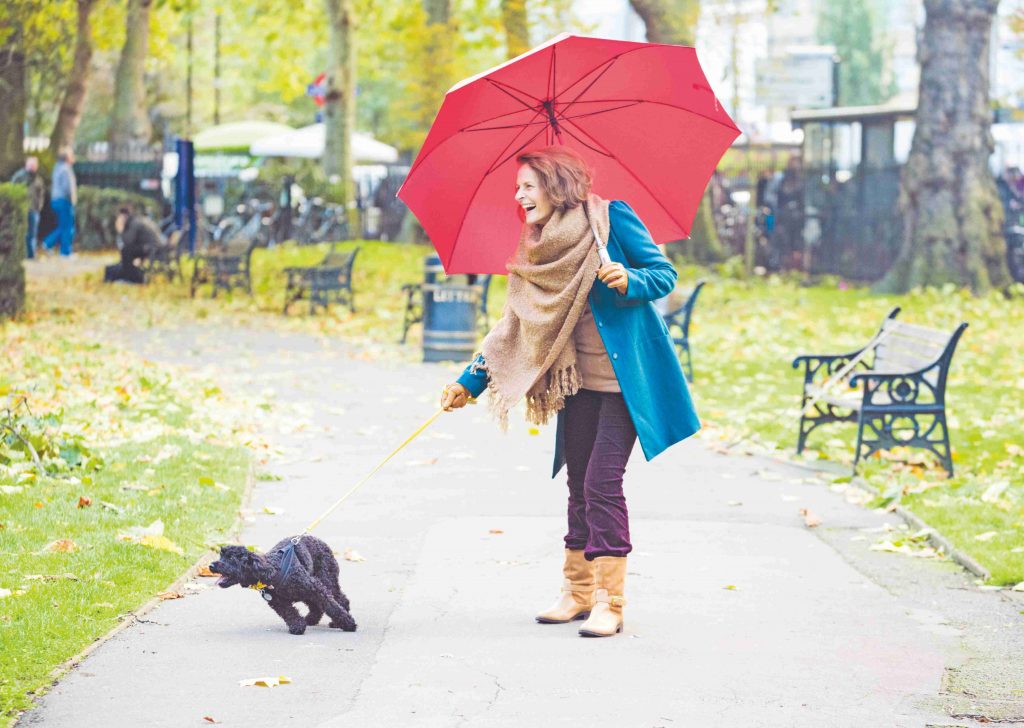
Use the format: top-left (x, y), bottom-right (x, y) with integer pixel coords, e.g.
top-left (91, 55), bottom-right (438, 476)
top-left (423, 283), bottom-right (480, 361)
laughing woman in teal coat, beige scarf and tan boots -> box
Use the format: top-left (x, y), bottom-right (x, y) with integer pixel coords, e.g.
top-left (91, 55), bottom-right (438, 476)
top-left (441, 146), bottom-right (700, 637)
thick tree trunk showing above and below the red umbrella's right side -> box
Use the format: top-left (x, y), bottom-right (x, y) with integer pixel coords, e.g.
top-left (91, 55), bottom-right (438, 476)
top-left (630, 0), bottom-right (726, 263)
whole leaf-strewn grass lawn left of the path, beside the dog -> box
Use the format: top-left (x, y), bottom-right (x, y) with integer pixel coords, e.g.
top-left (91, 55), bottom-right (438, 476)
top-left (0, 284), bottom-right (252, 722)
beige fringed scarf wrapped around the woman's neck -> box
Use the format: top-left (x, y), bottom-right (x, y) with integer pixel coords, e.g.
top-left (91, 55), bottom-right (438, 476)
top-left (482, 195), bottom-right (609, 428)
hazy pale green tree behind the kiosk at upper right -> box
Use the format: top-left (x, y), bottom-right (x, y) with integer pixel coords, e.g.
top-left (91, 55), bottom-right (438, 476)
top-left (818, 0), bottom-right (894, 105)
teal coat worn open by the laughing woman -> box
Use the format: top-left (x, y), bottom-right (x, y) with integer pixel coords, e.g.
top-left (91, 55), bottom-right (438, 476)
top-left (459, 201), bottom-right (700, 477)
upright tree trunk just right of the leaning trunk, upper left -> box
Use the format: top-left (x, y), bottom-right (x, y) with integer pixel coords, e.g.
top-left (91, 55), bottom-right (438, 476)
top-left (110, 0), bottom-right (153, 160)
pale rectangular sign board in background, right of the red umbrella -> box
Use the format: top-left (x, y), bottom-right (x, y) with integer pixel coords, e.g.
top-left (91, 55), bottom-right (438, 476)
top-left (755, 47), bottom-right (835, 109)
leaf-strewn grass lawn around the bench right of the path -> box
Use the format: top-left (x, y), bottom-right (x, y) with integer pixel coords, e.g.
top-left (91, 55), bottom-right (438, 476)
top-left (680, 269), bottom-right (1024, 585)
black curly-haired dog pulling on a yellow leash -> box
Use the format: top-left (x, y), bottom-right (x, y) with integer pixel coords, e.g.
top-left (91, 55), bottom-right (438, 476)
top-left (210, 536), bottom-right (355, 635)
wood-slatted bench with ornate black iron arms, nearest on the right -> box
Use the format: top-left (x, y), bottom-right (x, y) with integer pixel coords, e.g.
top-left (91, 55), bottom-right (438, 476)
top-left (793, 307), bottom-right (968, 477)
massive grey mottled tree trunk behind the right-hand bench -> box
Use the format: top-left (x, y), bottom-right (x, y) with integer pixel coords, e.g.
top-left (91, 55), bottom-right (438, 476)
top-left (877, 0), bottom-right (1010, 293)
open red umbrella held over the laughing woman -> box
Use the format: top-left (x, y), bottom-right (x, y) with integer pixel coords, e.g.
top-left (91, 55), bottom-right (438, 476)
top-left (398, 34), bottom-right (740, 273)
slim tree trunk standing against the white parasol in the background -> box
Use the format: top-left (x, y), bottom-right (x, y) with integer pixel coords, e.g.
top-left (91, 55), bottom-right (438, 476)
top-left (324, 0), bottom-right (355, 205)
